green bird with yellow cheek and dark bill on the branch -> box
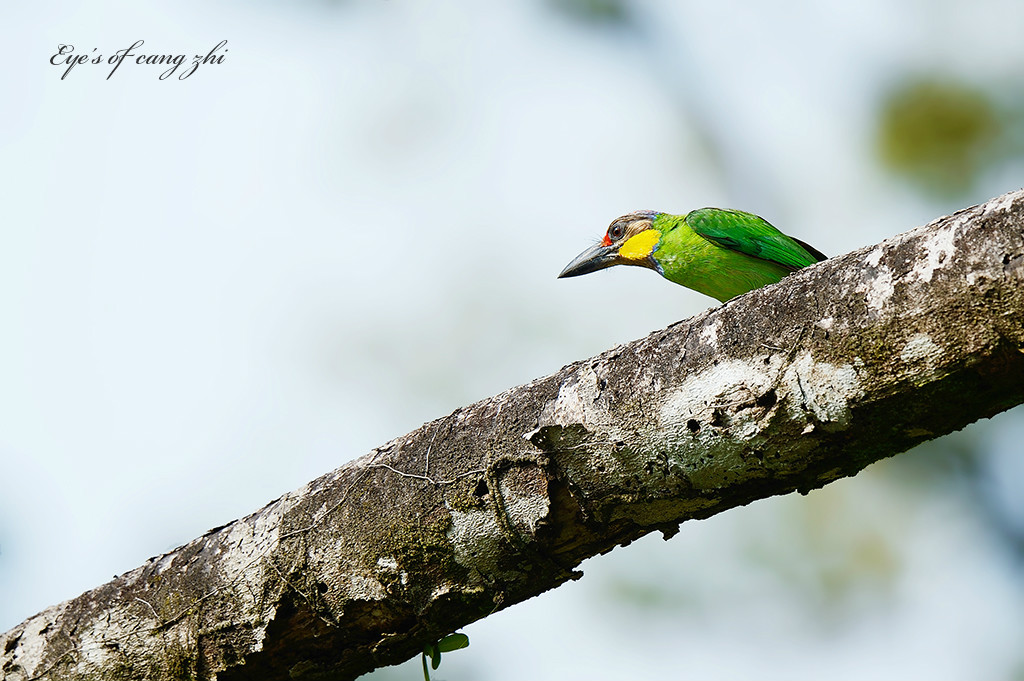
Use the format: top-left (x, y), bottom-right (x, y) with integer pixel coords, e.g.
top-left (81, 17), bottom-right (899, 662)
top-left (558, 208), bottom-right (825, 302)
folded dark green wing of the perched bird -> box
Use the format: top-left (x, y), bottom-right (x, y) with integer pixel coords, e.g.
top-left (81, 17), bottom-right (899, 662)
top-left (686, 208), bottom-right (825, 270)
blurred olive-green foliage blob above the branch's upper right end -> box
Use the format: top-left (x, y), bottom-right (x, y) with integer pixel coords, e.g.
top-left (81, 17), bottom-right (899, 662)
top-left (877, 77), bottom-right (1013, 199)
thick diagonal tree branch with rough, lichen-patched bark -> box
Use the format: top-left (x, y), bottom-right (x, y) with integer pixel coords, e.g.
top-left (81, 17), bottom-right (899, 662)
top-left (6, 190), bottom-right (1024, 681)
